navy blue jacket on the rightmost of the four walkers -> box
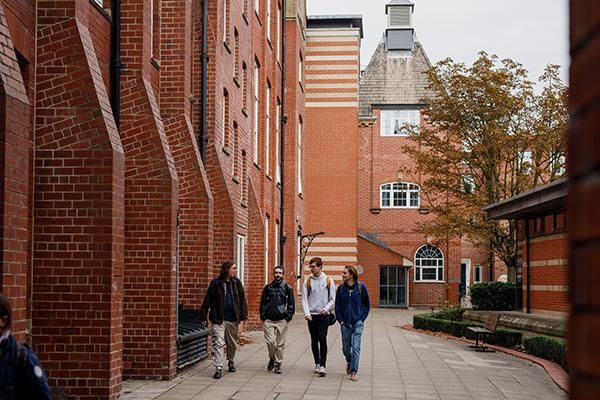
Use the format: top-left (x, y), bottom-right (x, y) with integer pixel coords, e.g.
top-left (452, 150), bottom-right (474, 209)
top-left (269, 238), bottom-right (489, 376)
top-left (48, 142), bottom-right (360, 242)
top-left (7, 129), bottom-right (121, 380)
top-left (335, 281), bottom-right (371, 325)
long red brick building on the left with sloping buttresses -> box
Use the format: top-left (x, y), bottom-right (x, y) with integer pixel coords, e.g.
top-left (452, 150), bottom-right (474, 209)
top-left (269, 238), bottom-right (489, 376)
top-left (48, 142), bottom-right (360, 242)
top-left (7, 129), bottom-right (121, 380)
top-left (0, 0), bottom-right (305, 399)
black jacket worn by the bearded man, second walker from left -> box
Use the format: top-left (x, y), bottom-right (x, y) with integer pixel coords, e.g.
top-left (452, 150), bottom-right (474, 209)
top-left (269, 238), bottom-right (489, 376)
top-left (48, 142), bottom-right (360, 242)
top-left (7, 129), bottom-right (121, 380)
top-left (260, 280), bottom-right (296, 322)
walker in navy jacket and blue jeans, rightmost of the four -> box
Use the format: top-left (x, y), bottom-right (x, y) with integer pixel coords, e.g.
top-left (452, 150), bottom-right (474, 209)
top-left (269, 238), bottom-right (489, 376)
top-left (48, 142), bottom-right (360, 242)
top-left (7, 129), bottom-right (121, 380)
top-left (335, 265), bottom-right (371, 382)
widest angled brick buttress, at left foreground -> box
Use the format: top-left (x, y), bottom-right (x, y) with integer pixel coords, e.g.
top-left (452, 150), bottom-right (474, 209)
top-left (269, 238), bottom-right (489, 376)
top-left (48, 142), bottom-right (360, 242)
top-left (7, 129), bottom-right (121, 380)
top-left (32, 0), bottom-right (124, 400)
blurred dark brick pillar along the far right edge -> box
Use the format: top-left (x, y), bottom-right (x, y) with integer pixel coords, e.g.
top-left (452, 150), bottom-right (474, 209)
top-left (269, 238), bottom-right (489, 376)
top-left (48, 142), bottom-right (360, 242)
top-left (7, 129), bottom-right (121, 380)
top-left (567, 0), bottom-right (600, 400)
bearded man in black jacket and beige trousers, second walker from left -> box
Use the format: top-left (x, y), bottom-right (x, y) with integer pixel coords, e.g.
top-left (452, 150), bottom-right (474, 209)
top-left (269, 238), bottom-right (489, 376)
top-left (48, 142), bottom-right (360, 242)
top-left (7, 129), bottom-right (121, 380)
top-left (260, 266), bottom-right (296, 374)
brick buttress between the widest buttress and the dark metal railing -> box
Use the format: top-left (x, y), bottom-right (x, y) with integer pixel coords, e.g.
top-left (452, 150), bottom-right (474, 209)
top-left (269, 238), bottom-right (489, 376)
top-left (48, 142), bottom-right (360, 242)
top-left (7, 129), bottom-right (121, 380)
top-left (120, 0), bottom-right (178, 379)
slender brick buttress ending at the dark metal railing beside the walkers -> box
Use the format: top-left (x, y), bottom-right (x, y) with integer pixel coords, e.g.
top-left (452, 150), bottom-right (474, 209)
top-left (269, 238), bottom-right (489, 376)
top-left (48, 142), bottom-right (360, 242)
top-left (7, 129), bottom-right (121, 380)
top-left (160, 0), bottom-right (213, 309)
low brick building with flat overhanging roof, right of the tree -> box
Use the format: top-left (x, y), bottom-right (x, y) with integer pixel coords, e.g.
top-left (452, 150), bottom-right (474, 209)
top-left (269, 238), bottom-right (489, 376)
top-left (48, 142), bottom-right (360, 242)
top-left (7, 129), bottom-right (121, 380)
top-left (485, 178), bottom-right (569, 316)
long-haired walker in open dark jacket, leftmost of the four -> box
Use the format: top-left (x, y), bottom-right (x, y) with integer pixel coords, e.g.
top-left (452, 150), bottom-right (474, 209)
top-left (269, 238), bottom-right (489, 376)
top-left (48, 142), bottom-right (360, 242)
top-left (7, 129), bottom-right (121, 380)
top-left (200, 261), bottom-right (248, 379)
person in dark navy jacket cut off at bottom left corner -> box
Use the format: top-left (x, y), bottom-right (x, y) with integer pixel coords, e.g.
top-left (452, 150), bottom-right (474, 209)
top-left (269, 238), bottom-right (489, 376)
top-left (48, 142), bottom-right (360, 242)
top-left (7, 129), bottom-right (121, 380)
top-left (0, 293), bottom-right (52, 400)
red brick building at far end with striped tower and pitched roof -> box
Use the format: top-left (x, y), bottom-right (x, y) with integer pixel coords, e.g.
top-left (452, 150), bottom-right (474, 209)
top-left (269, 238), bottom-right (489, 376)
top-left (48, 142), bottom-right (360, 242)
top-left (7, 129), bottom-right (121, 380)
top-left (306, 0), bottom-right (489, 307)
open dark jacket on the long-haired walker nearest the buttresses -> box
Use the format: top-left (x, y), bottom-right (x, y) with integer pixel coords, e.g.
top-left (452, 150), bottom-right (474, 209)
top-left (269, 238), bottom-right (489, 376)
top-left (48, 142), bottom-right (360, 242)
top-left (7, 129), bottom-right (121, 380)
top-left (200, 278), bottom-right (248, 325)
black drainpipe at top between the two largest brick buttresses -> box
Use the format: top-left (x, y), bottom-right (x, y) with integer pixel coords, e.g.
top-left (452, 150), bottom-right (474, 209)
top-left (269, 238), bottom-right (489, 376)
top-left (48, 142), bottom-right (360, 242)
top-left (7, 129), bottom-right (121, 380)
top-left (110, 0), bottom-right (123, 129)
